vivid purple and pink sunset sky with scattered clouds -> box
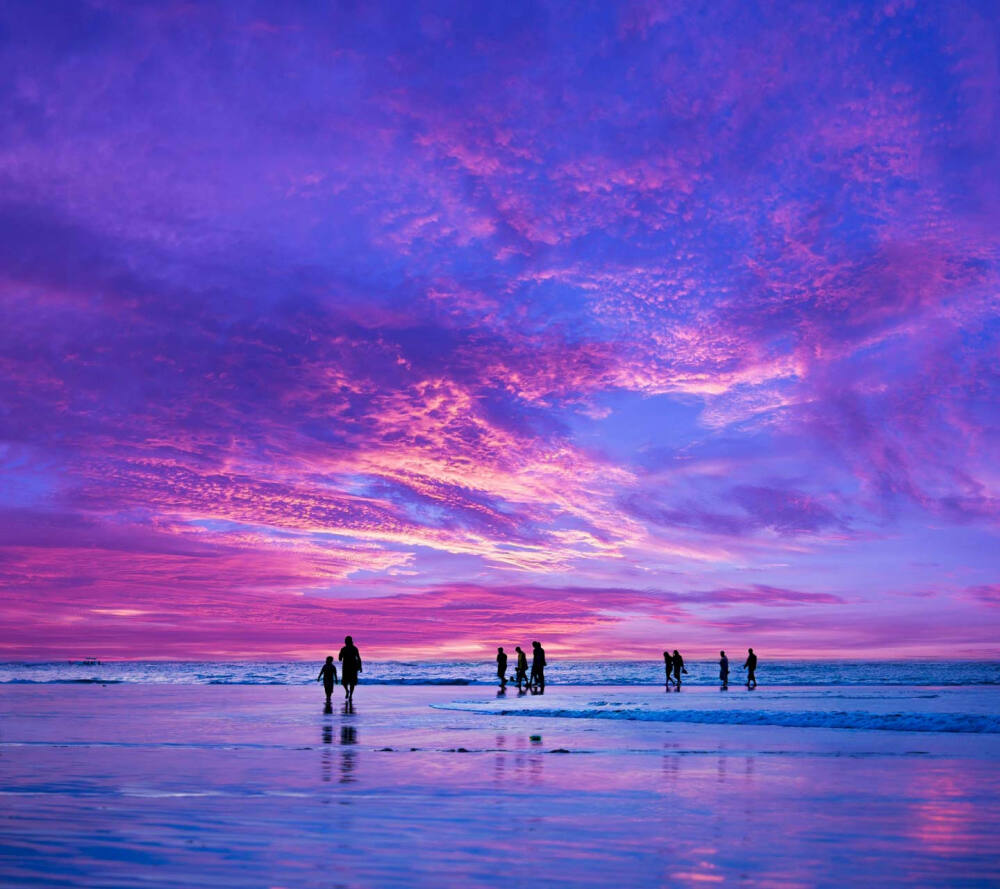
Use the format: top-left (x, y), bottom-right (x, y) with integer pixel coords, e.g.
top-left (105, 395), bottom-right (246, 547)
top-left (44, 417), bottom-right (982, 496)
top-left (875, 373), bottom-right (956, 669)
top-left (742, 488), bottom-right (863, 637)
top-left (0, 0), bottom-right (1000, 660)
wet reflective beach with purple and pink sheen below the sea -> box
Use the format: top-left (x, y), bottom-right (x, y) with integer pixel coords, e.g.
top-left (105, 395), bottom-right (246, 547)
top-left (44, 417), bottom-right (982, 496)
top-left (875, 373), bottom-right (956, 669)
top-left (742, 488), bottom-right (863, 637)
top-left (0, 682), bottom-right (1000, 889)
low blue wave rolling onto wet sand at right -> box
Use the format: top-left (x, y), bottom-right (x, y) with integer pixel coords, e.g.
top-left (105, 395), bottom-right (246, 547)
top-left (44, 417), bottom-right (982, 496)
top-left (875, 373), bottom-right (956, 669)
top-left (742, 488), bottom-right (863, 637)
top-left (431, 701), bottom-right (1000, 734)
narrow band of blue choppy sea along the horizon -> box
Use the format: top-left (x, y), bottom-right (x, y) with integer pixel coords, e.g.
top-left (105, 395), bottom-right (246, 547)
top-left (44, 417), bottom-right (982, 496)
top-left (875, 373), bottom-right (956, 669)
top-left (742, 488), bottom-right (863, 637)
top-left (0, 655), bottom-right (1000, 686)
